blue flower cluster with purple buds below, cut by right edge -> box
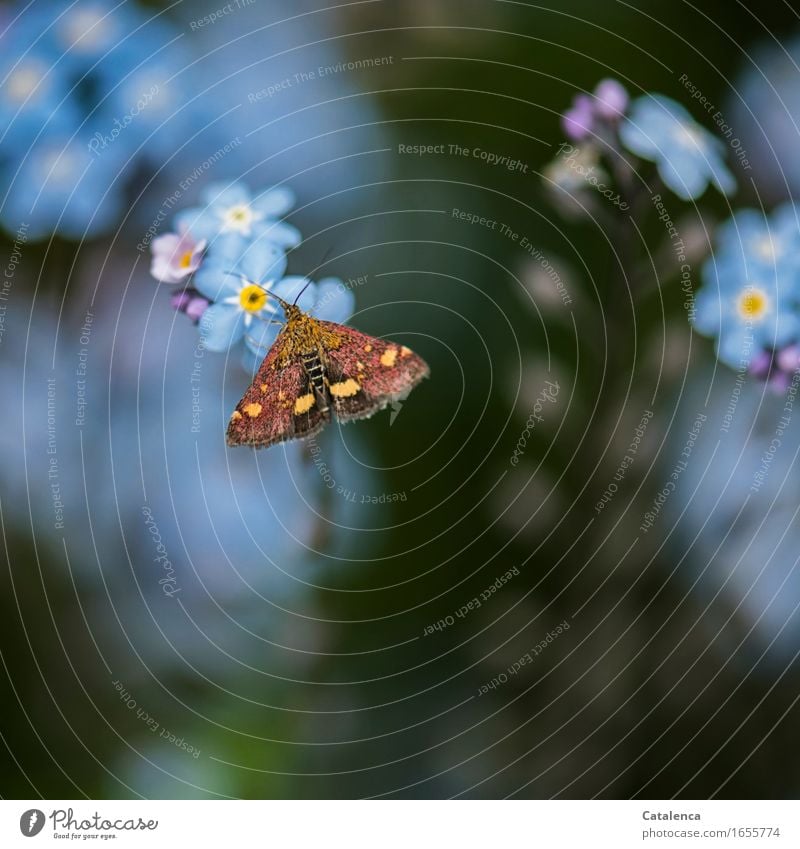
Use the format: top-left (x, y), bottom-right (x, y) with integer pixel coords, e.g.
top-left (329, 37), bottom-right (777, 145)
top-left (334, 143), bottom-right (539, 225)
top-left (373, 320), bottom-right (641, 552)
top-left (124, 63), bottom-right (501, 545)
top-left (694, 203), bottom-right (800, 388)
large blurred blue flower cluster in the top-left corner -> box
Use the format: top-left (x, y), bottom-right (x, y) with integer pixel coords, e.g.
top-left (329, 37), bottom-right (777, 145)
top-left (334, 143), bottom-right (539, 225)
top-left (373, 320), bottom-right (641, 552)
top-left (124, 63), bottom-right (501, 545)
top-left (0, 0), bottom-right (191, 238)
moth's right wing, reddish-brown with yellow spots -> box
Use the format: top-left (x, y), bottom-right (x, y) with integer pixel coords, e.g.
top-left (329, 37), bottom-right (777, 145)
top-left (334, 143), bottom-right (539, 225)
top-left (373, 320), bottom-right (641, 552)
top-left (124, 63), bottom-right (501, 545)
top-left (320, 321), bottom-right (430, 422)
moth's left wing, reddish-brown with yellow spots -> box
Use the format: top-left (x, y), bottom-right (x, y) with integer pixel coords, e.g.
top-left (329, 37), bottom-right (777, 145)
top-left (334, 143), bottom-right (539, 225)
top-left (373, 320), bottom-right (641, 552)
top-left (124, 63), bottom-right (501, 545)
top-left (227, 340), bottom-right (330, 448)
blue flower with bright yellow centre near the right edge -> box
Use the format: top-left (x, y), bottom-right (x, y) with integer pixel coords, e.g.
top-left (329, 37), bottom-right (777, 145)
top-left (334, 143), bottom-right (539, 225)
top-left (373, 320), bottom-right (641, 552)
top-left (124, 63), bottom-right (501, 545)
top-left (694, 248), bottom-right (800, 369)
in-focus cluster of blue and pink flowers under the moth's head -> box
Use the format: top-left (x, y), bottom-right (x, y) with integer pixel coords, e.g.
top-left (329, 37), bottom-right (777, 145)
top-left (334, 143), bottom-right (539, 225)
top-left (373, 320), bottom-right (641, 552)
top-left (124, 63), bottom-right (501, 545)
top-left (150, 182), bottom-right (354, 371)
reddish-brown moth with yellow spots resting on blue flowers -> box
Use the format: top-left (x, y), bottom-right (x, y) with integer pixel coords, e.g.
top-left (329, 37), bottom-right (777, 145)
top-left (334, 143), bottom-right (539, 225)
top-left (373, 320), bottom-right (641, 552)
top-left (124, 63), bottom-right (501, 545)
top-left (227, 293), bottom-right (430, 448)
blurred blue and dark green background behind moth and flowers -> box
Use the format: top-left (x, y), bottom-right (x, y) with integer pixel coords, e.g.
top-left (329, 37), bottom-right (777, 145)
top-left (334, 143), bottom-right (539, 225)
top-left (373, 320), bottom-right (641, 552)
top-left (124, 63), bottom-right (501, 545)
top-left (0, 0), bottom-right (800, 798)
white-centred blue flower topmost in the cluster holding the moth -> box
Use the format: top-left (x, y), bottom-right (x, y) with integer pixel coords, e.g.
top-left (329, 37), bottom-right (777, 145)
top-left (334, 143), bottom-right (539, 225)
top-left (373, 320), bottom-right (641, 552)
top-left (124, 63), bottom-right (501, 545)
top-left (176, 183), bottom-right (300, 248)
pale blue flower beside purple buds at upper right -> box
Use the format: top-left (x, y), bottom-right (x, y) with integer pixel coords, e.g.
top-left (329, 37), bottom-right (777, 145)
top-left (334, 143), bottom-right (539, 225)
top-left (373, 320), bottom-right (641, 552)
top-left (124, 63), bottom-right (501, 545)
top-left (619, 94), bottom-right (736, 200)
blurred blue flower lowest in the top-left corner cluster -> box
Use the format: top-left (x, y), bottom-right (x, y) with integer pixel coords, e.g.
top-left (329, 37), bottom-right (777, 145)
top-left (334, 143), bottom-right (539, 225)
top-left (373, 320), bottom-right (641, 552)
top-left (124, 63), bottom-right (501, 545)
top-left (0, 136), bottom-right (123, 239)
